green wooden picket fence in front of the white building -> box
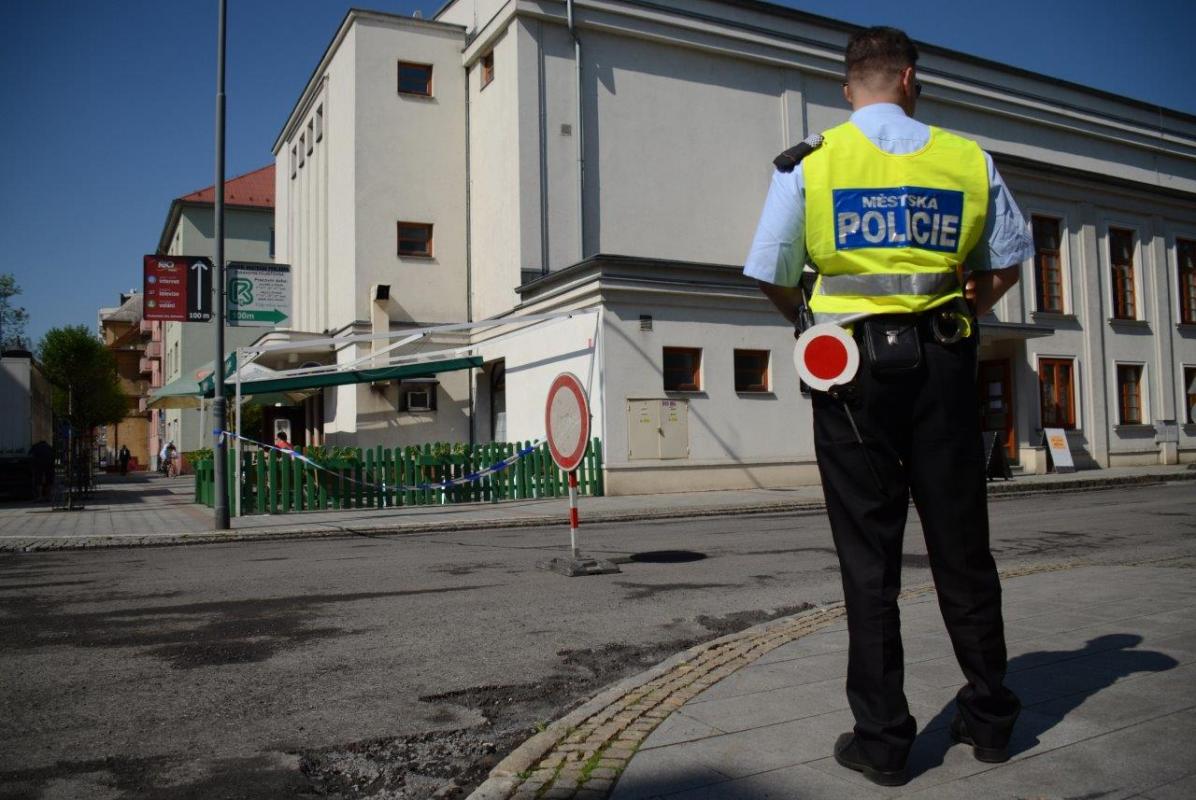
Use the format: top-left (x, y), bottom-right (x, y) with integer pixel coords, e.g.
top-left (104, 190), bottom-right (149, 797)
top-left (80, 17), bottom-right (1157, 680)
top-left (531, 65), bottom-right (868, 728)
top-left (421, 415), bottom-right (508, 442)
top-left (194, 438), bottom-right (603, 514)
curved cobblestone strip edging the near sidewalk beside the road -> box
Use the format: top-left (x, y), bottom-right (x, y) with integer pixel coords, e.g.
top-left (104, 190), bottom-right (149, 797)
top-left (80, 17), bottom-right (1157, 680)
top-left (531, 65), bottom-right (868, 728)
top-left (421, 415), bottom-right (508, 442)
top-left (469, 561), bottom-right (1086, 800)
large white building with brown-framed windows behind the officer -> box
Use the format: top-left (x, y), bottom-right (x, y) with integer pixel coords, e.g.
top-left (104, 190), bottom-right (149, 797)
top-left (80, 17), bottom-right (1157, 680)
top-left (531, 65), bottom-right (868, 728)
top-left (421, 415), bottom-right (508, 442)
top-left (273, 0), bottom-right (1196, 493)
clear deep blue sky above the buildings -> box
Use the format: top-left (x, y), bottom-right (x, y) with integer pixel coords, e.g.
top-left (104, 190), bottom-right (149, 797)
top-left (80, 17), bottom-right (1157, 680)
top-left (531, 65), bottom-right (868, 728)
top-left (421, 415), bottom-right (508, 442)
top-left (0, 0), bottom-right (1196, 341)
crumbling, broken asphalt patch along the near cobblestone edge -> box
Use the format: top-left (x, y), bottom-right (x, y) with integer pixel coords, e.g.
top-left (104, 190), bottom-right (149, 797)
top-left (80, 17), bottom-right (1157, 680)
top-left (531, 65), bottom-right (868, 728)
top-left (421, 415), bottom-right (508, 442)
top-left (303, 603), bottom-right (812, 800)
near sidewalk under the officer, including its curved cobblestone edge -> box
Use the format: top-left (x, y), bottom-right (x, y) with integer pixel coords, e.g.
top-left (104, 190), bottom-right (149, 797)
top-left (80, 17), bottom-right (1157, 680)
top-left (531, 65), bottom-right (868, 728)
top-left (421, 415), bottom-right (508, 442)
top-left (471, 557), bottom-right (1196, 800)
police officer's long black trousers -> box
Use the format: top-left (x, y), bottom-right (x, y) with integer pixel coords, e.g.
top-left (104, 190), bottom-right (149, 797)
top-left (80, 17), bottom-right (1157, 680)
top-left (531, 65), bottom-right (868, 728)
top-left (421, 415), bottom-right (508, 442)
top-left (813, 322), bottom-right (1020, 769)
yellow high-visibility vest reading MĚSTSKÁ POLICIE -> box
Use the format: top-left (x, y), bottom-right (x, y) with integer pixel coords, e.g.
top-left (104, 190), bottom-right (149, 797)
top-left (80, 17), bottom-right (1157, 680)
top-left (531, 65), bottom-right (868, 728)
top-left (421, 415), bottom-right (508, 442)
top-left (801, 122), bottom-right (988, 322)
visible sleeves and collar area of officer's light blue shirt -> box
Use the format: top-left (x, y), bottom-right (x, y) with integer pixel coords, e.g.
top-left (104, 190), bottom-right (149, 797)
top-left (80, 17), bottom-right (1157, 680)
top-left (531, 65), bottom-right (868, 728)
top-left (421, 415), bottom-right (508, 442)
top-left (744, 103), bottom-right (1035, 286)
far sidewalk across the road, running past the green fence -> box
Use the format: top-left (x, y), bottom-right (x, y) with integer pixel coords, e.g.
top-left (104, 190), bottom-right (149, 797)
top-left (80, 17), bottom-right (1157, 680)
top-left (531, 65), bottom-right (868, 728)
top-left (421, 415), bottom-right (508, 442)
top-left (0, 465), bottom-right (1196, 551)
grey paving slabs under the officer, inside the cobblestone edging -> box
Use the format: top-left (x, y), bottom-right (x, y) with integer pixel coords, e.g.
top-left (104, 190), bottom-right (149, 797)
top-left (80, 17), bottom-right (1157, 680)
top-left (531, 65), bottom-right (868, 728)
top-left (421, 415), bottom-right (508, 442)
top-left (610, 566), bottom-right (1196, 800)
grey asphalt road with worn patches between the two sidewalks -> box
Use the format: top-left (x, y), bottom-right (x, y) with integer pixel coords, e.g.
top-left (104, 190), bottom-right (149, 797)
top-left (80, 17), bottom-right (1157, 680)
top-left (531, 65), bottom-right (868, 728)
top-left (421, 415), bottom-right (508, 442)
top-left (0, 483), bottom-right (1196, 800)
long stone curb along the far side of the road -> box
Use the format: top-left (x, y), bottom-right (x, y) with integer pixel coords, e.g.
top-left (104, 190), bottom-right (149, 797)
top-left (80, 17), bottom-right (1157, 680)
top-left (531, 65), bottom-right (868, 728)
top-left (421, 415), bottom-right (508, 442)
top-left (0, 470), bottom-right (1196, 552)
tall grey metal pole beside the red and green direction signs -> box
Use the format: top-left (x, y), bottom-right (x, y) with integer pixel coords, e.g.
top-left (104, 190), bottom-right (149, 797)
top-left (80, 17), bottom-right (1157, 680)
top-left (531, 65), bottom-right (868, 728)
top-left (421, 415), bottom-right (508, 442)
top-left (212, 0), bottom-right (228, 531)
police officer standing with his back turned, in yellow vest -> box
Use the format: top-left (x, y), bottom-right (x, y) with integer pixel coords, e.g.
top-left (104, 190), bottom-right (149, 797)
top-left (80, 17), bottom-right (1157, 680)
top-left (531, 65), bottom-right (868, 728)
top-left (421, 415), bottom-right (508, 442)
top-left (744, 28), bottom-right (1033, 786)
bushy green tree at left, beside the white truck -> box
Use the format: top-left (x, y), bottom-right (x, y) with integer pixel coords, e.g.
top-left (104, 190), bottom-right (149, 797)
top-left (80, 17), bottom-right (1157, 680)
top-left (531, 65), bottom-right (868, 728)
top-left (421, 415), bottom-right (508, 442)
top-left (37, 325), bottom-right (129, 432)
